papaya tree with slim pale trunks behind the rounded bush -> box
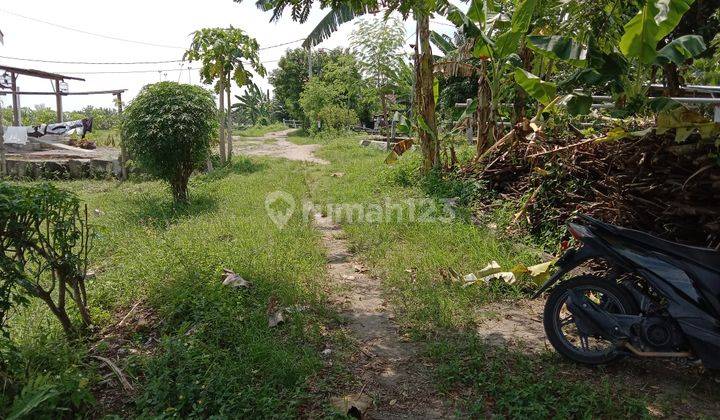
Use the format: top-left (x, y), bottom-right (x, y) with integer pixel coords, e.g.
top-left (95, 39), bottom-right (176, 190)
top-left (185, 26), bottom-right (265, 163)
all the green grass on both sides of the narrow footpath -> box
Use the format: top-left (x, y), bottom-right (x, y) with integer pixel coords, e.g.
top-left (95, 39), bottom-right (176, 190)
top-left (0, 133), bottom-right (680, 418)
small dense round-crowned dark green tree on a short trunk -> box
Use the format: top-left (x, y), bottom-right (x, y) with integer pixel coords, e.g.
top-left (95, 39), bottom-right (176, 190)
top-left (122, 82), bottom-right (217, 202)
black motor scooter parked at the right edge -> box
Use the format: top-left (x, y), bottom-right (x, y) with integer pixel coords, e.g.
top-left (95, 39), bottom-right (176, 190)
top-left (533, 215), bottom-right (720, 369)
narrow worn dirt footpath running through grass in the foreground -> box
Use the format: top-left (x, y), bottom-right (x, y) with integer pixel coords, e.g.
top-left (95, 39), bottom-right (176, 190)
top-left (315, 214), bottom-right (452, 419)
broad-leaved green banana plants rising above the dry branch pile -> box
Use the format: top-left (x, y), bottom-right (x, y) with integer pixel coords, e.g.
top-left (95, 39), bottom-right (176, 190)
top-left (438, 0), bottom-right (706, 155)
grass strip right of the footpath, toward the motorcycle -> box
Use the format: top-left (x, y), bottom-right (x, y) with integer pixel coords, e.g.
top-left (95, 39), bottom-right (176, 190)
top-left (298, 137), bottom-right (647, 418)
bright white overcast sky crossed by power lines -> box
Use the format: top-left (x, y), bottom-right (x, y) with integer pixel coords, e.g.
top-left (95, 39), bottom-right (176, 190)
top-left (0, 0), bottom-right (462, 111)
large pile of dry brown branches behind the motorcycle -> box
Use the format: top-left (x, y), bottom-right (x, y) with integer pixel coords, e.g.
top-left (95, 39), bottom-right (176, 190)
top-left (463, 120), bottom-right (720, 247)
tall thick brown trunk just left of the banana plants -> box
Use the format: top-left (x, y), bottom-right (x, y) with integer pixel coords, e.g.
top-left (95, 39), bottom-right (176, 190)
top-left (415, 13), bottom-right (439, 172)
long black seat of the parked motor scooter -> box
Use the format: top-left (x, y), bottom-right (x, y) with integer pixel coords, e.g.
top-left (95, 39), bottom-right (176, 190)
top-left (581, 215), bottom-right (720, 271)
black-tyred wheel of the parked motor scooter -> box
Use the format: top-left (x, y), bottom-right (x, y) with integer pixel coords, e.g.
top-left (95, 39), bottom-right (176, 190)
top-left (543, 275), bottom-right (636, 365)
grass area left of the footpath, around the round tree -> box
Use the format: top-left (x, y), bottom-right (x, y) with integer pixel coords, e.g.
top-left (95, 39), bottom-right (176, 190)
top-left (2, 158), bottom-right (346, 417)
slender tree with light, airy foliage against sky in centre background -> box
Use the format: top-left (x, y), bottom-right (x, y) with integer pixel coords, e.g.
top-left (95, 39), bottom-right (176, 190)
top-left (350, 18), bottom-right (405, 127)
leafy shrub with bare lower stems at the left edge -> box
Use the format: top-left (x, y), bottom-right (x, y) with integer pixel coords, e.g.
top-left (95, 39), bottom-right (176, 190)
top-left (0, 182), bottom-right (91, 338)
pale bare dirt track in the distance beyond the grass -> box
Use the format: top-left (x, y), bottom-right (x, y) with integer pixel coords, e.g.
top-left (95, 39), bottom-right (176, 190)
top-left (233, 129), bottom-right (330, 165)
